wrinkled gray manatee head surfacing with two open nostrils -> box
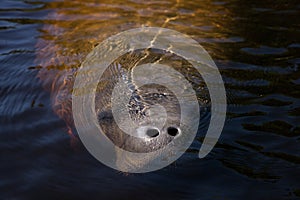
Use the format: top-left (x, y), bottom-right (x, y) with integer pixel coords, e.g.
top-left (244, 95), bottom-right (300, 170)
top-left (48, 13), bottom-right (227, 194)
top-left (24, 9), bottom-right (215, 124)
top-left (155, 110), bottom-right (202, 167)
top-left (91, 49), bottom-right (209, 171)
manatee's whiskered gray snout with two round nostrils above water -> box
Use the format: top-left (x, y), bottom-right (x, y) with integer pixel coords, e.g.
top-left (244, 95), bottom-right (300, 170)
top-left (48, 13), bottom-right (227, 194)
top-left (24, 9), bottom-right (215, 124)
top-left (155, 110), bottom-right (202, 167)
top-left (98, 108), bottom-right (182, 171)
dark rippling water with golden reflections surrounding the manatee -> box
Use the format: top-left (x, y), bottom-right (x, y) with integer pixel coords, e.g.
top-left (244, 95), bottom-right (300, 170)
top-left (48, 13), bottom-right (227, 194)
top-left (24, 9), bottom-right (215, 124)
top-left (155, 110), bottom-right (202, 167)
top-left (0, 0), bottom-right (300, 199)
